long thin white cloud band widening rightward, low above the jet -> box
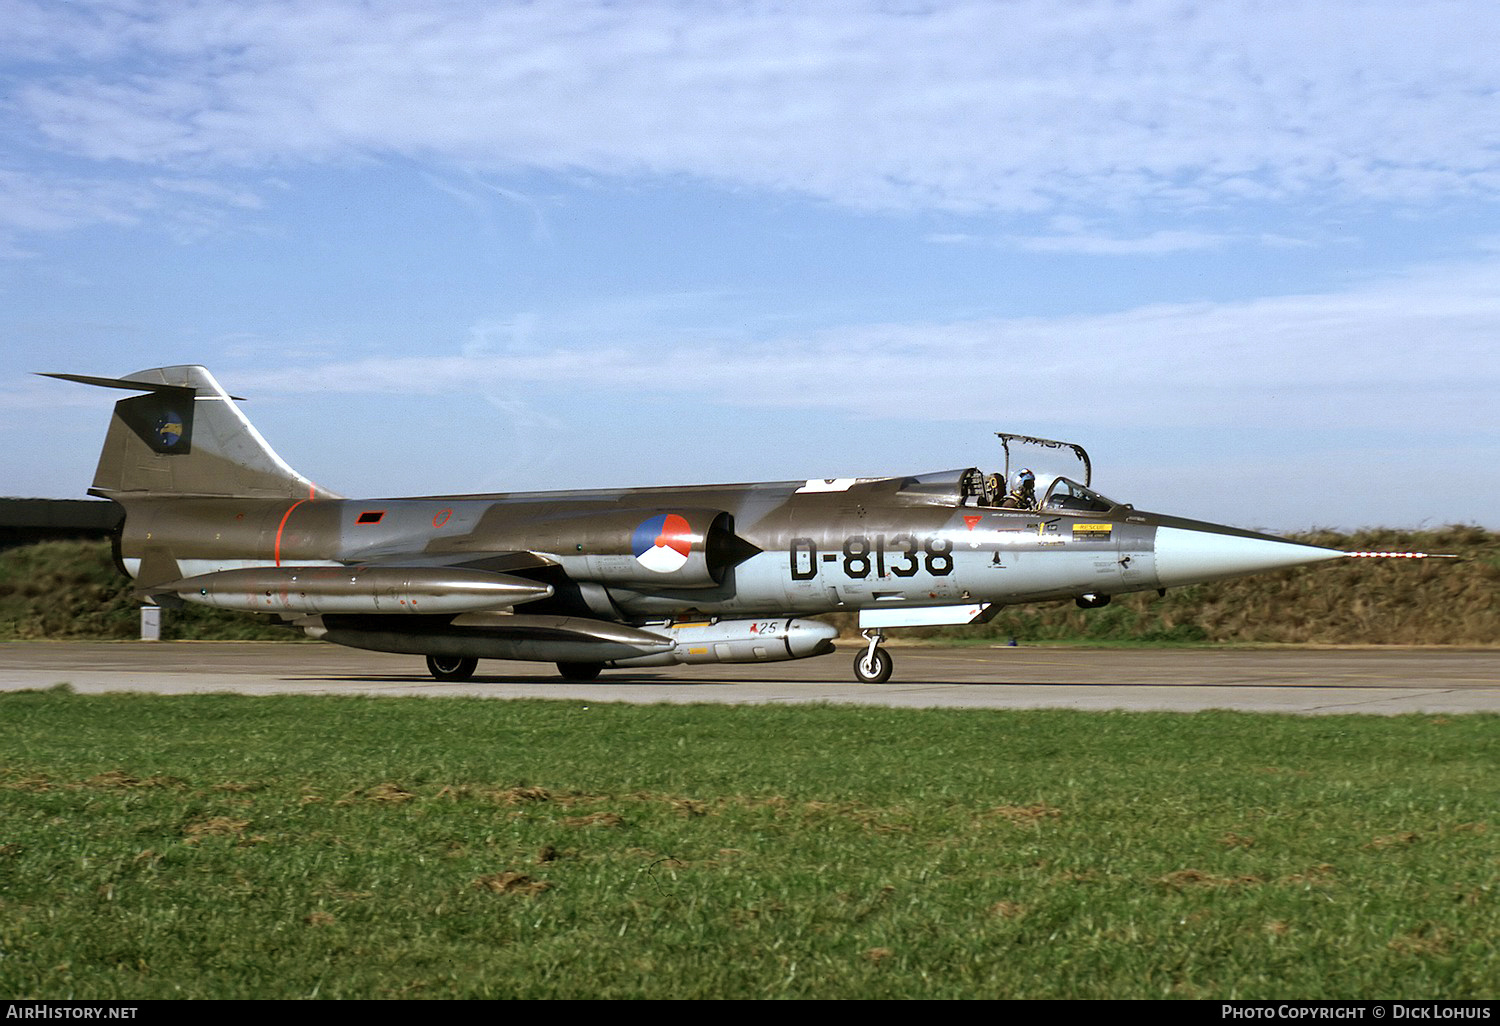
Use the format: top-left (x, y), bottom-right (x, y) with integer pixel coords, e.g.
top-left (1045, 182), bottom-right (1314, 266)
top-left (237, 263), bottom-right (1500, 438)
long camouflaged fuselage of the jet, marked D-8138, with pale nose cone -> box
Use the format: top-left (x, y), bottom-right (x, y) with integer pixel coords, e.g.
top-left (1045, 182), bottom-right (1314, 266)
top-left (120, 471), bottom-right (1343, 618)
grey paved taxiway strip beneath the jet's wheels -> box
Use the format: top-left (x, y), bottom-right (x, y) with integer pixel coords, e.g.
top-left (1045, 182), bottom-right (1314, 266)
top-left (0, 642), bottom-right (1500, 716)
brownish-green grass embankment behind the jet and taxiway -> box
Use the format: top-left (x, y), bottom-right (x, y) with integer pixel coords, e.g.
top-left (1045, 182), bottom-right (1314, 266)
top-left (0, 527), bottom-right (1500, 645)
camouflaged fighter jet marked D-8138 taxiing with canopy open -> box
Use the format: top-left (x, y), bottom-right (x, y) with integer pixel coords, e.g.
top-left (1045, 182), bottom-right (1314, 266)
top-left (47, 366), bottom-right (1346, 683)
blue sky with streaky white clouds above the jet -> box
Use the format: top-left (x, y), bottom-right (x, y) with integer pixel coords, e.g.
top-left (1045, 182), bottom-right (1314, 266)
top-left (0, 0), bottom-right (1500, 530)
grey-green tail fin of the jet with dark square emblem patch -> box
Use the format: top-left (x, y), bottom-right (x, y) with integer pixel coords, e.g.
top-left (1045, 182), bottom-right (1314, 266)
top-left (44, 366), bottom-right (339, 501)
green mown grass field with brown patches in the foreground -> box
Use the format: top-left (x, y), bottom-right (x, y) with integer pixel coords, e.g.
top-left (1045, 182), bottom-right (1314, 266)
top-left (0, 690), bottom-right (1500, 999)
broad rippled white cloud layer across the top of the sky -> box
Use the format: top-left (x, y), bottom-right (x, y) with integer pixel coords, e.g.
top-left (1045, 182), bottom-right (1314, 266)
top-left (9, 0), bottom-right (1500, 226)
